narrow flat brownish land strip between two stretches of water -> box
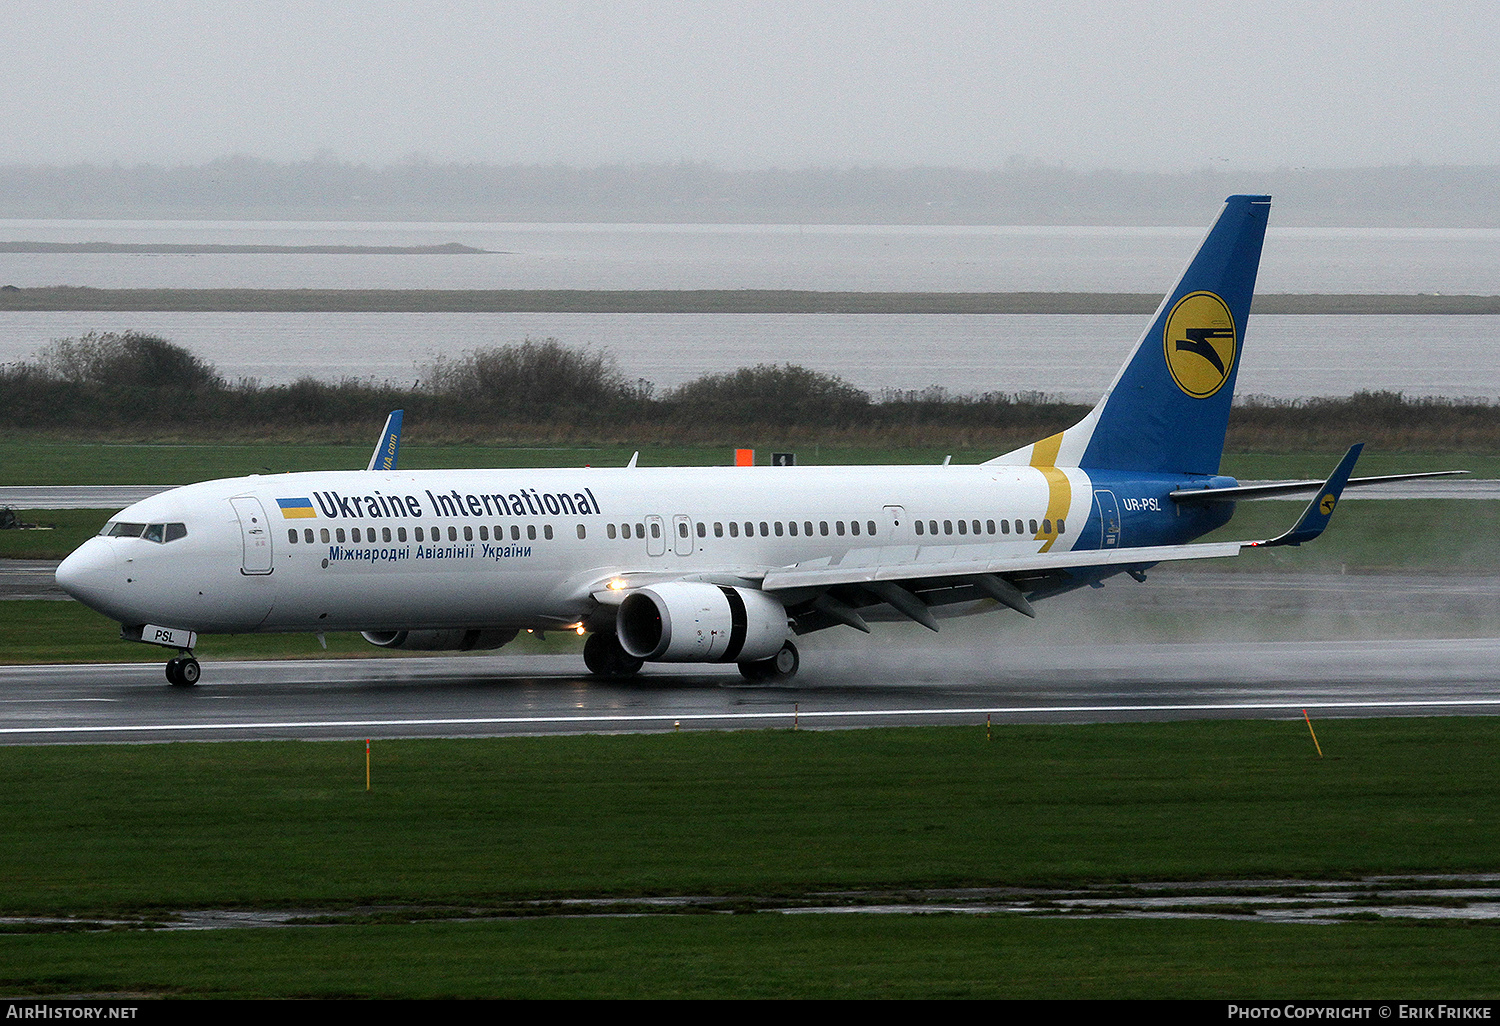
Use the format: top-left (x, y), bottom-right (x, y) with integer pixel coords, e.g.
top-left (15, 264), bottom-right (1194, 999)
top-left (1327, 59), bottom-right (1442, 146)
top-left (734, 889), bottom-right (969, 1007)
top-left (0, 285), bottom-right (1500, 315)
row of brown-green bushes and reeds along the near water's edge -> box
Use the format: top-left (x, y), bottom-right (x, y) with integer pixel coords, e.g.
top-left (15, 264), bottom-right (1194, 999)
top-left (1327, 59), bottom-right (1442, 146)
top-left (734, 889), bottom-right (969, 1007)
top-left (0, 332), bottom-right (1500, 452)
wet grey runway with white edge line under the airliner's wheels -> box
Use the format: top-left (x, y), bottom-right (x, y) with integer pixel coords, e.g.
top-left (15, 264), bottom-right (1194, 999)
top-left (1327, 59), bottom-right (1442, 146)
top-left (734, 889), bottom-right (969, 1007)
top-left (0, 639), bottom-right (1500, 744)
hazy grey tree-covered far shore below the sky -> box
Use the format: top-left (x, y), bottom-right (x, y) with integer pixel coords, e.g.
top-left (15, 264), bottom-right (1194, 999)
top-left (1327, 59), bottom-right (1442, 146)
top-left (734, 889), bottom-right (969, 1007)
top-left (0, 156), bottom-right (1500, 226)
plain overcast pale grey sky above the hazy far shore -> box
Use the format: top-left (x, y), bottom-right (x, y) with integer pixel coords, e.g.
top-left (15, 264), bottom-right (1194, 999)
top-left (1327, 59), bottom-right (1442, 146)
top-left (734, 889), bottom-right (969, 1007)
top-left (0, 0), bottom-right (1500, 171)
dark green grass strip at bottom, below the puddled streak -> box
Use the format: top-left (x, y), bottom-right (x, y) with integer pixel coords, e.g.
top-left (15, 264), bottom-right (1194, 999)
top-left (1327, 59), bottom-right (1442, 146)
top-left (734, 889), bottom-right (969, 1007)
top-left (0, 914), bottom-right (1500, 1001)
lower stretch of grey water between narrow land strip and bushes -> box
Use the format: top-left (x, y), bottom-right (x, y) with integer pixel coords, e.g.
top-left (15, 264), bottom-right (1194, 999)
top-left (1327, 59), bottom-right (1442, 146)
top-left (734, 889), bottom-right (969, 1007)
top-left (0, 312), bottom-right (1500, 402)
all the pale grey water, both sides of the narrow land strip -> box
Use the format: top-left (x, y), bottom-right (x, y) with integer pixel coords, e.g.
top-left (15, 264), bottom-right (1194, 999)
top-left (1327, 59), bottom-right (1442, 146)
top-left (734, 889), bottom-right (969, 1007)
top-left (0, 218), bottom-right (1500, 401)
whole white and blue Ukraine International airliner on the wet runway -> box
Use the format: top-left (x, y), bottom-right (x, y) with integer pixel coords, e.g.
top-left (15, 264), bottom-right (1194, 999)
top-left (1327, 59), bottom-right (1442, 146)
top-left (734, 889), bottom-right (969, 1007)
top-left (57, 197), bottom-right (1452, 684)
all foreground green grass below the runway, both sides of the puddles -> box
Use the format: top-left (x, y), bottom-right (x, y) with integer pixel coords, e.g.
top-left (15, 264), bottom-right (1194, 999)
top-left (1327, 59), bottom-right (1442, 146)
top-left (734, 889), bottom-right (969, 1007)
top-left (0, 719), bottom-right (1500, 998)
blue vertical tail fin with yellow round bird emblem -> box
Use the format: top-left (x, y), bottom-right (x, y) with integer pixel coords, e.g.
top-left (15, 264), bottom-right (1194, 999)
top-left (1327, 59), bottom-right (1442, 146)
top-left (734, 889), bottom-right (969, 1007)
top-left (992, 197), bottom-right (1271, 474)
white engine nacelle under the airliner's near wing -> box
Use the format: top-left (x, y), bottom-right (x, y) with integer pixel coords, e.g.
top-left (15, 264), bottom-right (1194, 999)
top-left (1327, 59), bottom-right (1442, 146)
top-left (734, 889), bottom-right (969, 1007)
top-left (615, 581), bottom-right (788, 663)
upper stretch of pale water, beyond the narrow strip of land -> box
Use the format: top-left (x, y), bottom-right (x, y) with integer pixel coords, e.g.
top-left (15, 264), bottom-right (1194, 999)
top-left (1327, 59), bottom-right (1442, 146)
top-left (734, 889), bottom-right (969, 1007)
top-left (0, 219), bottom-right (1500, 296)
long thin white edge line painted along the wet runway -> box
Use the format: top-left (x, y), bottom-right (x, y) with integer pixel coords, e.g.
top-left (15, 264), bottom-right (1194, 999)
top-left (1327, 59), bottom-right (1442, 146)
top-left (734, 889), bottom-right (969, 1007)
top-left (0, 698), bottom-right (1500, 735)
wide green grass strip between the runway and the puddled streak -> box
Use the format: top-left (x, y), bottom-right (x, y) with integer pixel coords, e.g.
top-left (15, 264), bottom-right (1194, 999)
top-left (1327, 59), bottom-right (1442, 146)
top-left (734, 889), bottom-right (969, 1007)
top-left (0, 720), bottom-right (1500, 914)
